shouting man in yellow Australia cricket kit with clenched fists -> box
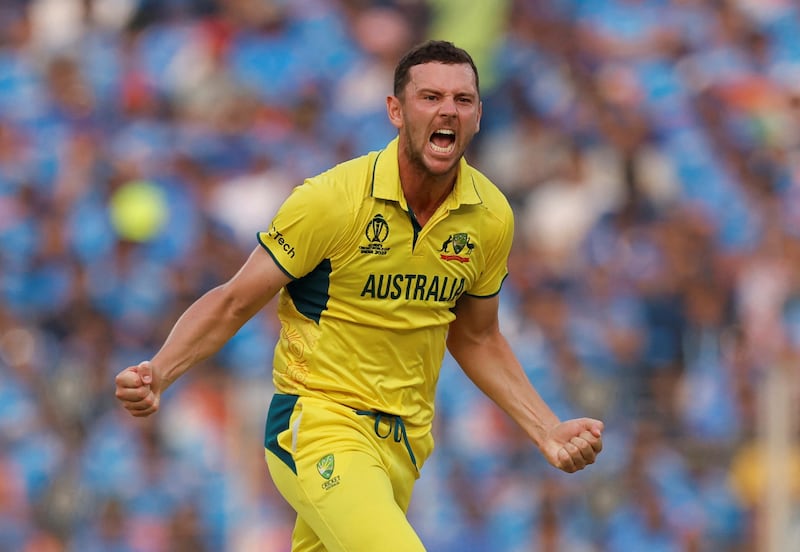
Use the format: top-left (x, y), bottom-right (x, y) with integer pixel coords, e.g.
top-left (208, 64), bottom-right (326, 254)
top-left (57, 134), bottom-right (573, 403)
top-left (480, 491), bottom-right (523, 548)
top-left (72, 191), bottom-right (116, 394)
top-left (116, 41), bottom-right (603, 552)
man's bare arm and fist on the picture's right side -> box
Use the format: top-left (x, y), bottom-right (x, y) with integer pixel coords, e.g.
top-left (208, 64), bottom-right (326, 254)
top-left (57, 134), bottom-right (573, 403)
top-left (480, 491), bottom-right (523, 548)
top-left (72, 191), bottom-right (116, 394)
top-left (447, 295), bottom-right (603, 473)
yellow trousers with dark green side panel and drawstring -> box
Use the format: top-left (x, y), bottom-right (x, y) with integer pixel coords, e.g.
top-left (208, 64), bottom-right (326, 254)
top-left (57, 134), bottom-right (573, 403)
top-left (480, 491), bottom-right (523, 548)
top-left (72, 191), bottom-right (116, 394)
top-left (264, 394), bottom-right (433, 552)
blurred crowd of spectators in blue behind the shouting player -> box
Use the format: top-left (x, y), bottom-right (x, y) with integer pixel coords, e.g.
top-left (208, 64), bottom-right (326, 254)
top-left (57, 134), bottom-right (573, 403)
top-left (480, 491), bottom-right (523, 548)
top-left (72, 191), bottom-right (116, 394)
top-left (0, 0), bottom-right (800, 552)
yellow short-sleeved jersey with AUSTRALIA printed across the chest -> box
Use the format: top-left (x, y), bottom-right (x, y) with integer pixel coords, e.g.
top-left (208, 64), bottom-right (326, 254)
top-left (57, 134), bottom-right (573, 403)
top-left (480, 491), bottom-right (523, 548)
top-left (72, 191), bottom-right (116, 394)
top-left (258, 138), bottom-right (514, 431)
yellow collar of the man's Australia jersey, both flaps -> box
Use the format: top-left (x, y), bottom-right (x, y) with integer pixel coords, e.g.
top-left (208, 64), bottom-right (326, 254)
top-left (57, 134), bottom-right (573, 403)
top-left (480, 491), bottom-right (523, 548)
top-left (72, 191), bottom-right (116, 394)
top-left (371, 138), bottom-right (482, 209)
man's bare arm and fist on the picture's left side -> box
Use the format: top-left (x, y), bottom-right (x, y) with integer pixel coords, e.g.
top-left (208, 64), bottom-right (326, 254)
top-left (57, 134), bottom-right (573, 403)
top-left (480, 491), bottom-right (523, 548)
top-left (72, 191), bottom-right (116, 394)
top-left (115, 246), bottom-right (290, 417)
